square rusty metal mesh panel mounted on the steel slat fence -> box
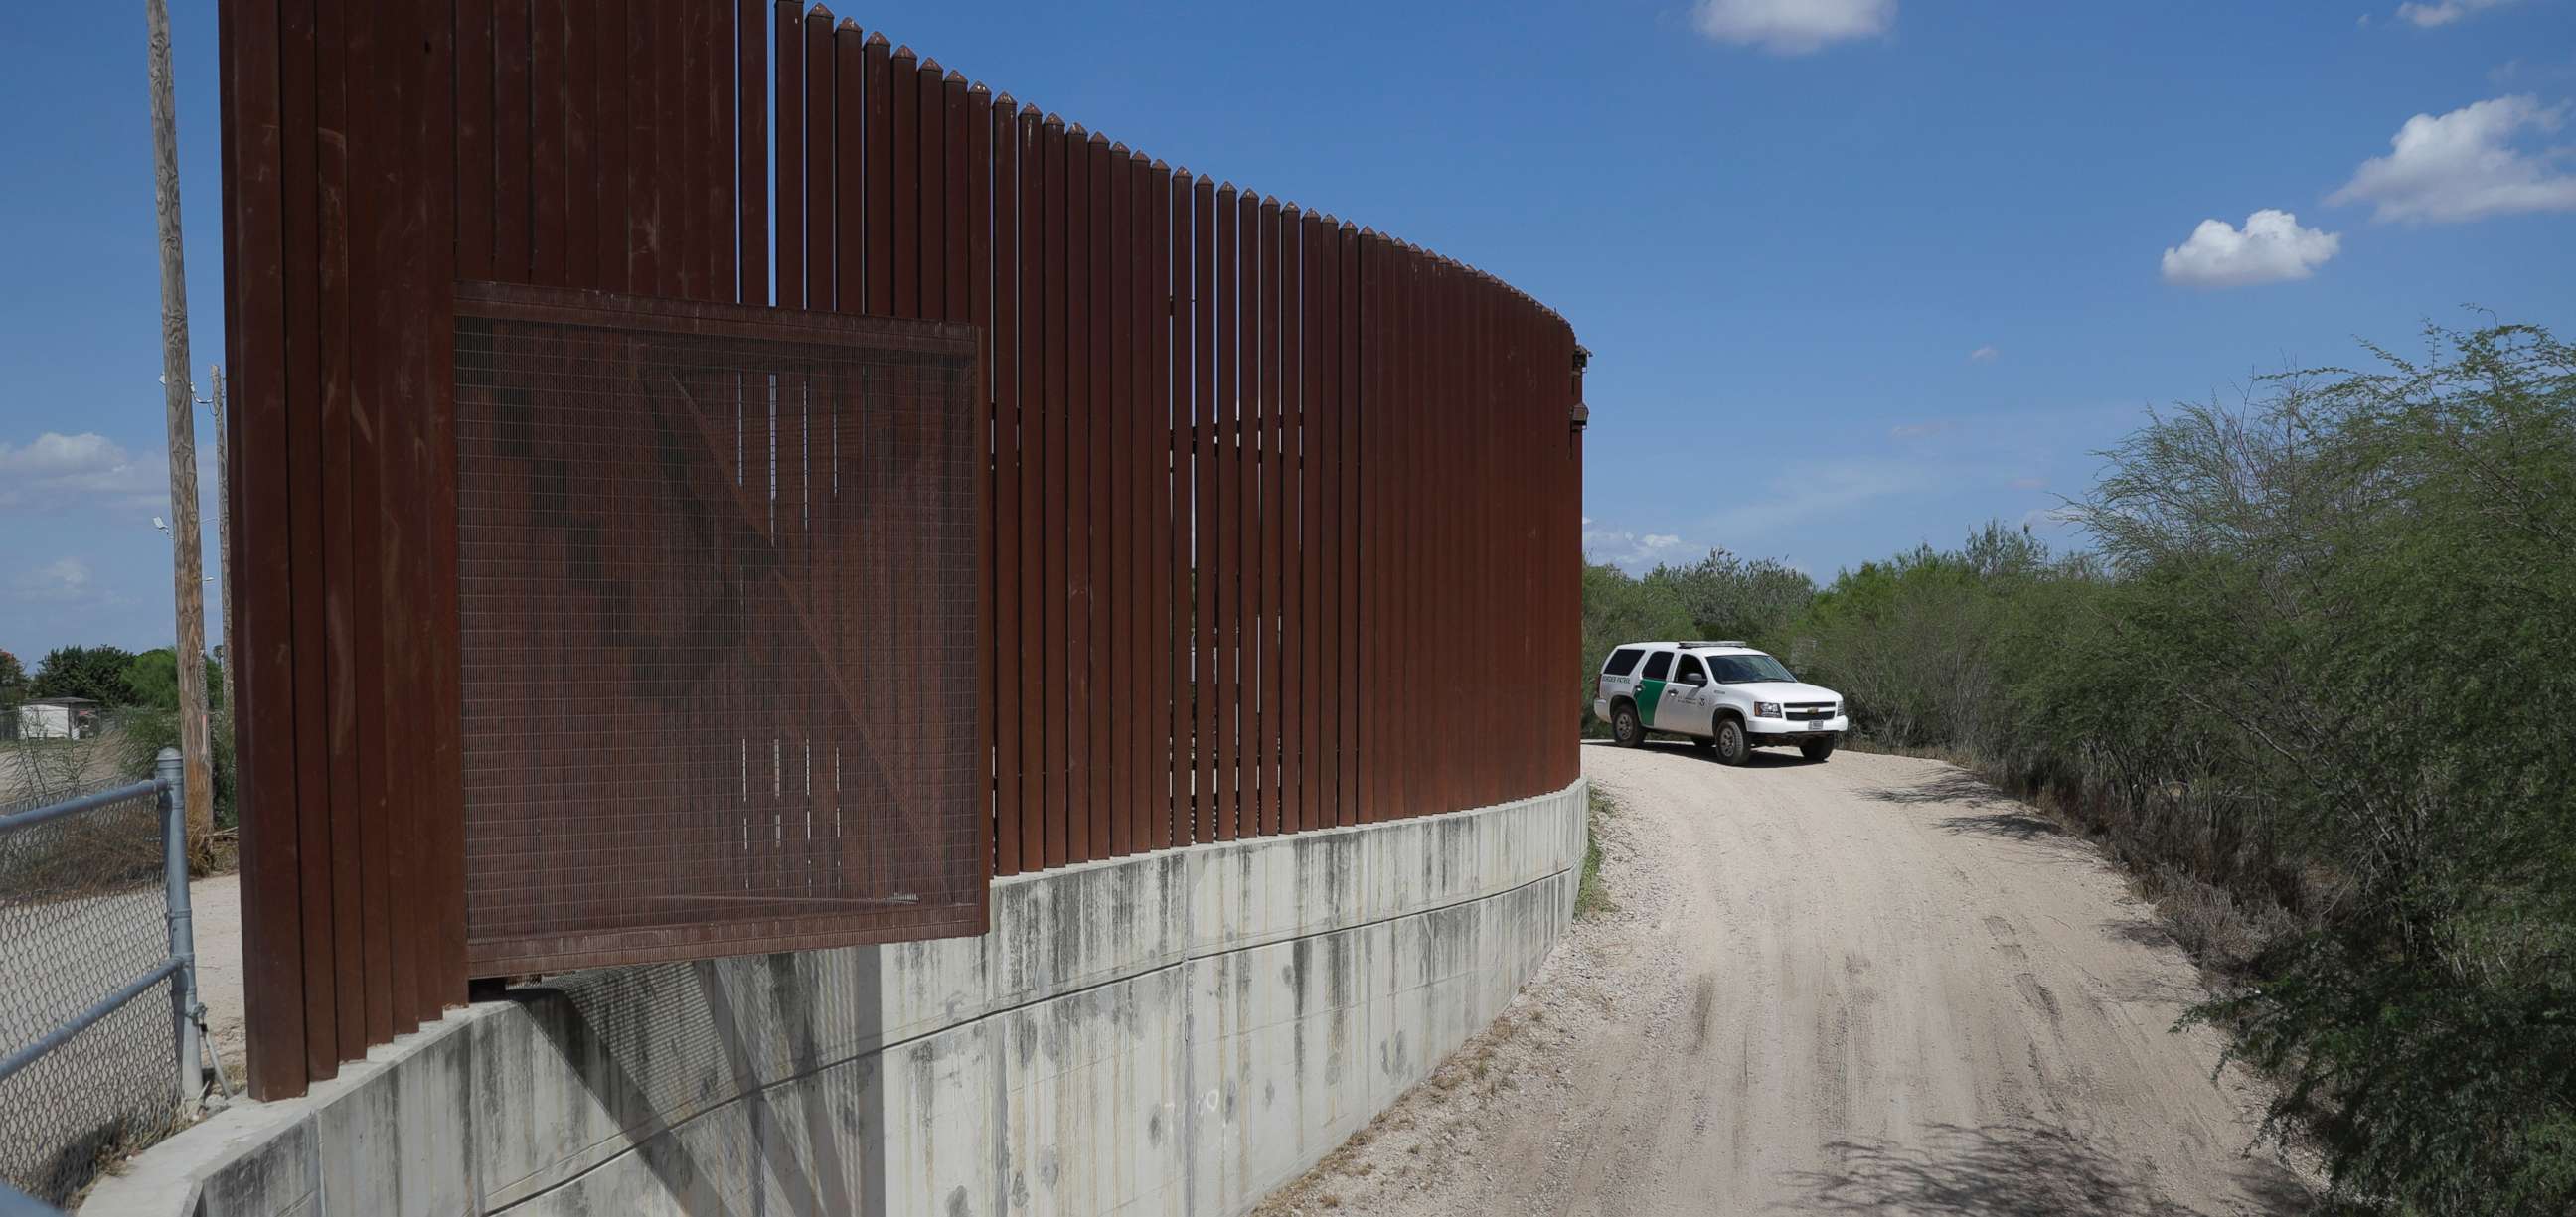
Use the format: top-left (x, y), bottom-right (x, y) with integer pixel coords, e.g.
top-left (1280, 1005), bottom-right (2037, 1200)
top-left (456, 288), bottom-right (987, 976)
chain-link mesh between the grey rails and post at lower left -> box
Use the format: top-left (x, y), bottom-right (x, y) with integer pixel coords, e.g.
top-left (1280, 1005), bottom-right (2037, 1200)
top-left (0, 793), bottom-right (178, 1201)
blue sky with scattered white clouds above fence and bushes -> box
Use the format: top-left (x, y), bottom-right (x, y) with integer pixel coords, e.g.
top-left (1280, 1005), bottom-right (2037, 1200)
top-left (0, 0), bottom-right (2576, 659)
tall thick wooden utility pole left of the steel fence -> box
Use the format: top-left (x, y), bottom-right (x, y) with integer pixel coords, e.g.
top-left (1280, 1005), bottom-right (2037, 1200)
top-left (144, 0), bottom-right (214, 856)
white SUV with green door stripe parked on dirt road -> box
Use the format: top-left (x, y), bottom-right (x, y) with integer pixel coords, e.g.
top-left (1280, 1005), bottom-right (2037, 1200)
top-left (1592, 641), bottom-right (1850, 764)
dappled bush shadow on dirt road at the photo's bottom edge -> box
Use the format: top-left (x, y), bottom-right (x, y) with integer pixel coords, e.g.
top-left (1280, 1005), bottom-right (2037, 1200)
top-left (1788, 1125), bottom-right (2314, 1217)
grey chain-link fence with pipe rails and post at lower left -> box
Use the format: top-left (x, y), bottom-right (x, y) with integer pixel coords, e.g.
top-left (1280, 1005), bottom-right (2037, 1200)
top-left (0, 749), bottom-right (204, 1204)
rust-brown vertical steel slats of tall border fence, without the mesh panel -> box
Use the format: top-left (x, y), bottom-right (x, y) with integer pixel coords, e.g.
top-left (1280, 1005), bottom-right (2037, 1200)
top-left (225, 0), bottom-right (1581, 1096)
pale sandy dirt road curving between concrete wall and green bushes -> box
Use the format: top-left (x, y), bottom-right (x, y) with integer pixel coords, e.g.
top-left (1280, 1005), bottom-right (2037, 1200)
top-left (1262, 746), bottom-right (2308, 1217)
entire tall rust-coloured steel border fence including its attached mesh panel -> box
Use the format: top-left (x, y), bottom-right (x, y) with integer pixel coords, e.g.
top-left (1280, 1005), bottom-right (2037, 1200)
top-left (222, 0), bottom-right (1581, 1096)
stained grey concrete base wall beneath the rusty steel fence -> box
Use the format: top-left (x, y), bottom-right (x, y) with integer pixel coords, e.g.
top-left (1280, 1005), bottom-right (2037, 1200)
top-left (82, 782), bottom-right (1584, 1217)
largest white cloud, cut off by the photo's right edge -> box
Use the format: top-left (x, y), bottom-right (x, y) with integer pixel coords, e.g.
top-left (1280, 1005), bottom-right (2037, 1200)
top-left (2327, 92), bottom-right (2576, 224)
